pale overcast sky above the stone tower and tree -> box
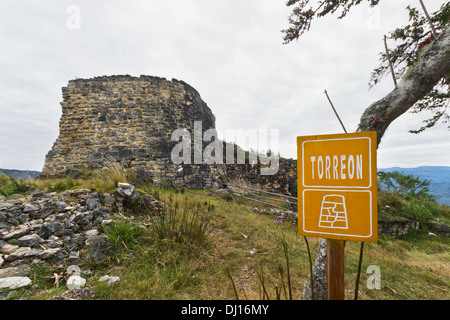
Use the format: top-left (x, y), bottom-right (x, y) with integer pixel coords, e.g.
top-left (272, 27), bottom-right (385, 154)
top-left (0, 0), bottom-right (450, 171)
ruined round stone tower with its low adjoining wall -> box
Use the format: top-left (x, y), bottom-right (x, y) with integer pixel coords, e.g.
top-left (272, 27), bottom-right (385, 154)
top-left (42, 75), bottom-right (297, 193)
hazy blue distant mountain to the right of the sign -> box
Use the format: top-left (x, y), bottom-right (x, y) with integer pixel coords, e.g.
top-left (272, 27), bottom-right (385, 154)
top-left (378, 166), bottom-right (450, 206)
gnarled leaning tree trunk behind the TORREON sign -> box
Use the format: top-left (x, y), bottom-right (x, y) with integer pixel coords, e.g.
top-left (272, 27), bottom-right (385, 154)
top-left (302, 25), bottom-right (450, 300)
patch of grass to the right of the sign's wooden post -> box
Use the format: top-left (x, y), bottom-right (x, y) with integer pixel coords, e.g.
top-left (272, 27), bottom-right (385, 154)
top-left (346, 232), bottom-right (450, 300)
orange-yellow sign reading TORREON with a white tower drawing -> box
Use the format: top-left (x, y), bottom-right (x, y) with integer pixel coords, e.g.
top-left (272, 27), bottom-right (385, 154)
top-left (297, 132), bottom-right (378, 242)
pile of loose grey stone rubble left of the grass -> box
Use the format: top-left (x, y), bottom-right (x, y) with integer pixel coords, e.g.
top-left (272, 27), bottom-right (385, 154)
top-left (0, 183), bottom-right (164, 298)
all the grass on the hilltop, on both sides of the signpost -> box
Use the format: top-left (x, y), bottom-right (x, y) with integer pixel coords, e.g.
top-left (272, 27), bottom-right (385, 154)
top-left (4, 176), bottom-right (450, 300)
